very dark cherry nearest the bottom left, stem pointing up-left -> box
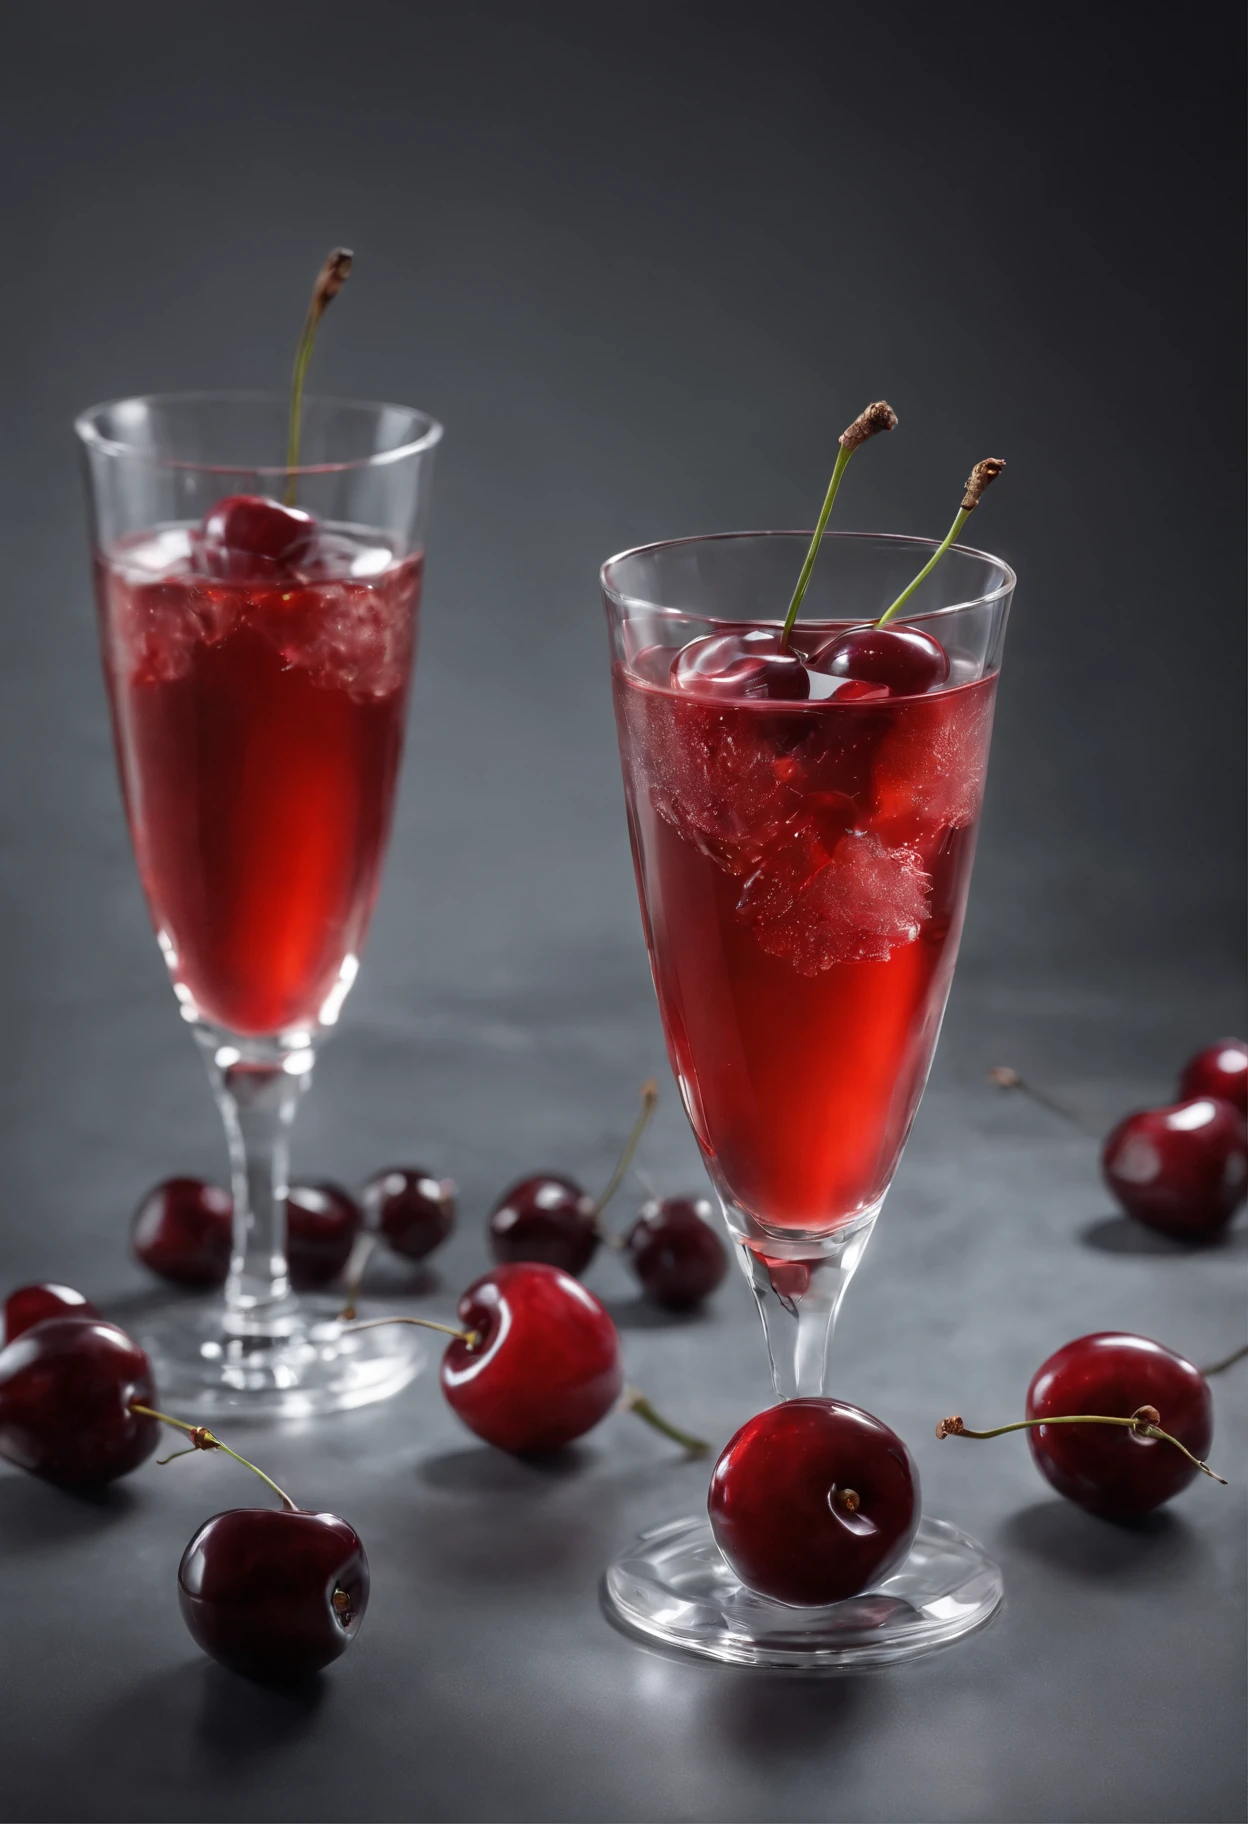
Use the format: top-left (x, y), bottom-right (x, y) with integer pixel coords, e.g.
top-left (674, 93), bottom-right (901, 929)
top-left (177, 1507), bottom-right (369, 1682)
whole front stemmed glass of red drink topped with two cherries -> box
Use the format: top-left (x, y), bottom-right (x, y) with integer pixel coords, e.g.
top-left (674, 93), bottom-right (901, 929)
top-left (602, 533), bottom-right (1014, 1665)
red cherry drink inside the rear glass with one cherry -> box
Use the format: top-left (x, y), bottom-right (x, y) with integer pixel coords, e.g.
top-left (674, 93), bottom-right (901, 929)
top-left (95, 527), bottom-right (421, 1036)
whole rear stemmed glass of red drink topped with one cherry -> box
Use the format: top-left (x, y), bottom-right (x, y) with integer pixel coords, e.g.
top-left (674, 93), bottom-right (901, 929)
top-left (75, 394), bottom-right (442, 1415)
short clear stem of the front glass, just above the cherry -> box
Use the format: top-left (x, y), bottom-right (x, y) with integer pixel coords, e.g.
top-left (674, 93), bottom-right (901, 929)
top-left (737, 1209), bottom-right (876, 1399)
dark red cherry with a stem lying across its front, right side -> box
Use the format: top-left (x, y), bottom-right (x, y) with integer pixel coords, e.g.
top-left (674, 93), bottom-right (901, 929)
top-left (1027, 1330), bottom-right (1213, 1519)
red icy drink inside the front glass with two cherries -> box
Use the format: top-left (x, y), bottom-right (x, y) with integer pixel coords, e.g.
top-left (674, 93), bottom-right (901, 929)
top-left (613, 648), bottom-right (996, 1235)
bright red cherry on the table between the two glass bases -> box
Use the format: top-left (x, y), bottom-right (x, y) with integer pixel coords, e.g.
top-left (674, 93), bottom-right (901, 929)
top-left (442, 1260), bottom-right (624, 1456)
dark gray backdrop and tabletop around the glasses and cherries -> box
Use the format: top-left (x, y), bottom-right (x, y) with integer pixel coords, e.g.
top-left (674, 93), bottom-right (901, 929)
top-left (0, 10), bottom-right (1244, 1820)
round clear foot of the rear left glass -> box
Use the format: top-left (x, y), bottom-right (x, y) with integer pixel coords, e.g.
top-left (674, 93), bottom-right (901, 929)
top-left (131, 1293), bottom-right (429, 1421)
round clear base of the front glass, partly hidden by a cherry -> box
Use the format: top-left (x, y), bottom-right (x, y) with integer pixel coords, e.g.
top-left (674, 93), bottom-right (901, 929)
top-left (606, 1518), bottom-right (1004, 1673)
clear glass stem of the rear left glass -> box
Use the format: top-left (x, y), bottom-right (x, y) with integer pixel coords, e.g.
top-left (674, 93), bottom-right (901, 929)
top-left (204, 1036), bottom-right (312, 1337)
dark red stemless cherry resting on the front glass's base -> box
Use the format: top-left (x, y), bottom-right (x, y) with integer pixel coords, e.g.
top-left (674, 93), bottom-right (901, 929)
top-left (708, 1399), bottom-right (920, 1607)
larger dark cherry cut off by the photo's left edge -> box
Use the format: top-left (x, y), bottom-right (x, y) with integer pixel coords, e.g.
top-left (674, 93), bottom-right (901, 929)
top-left (0, 1317), bottom-right (161, 1488)
